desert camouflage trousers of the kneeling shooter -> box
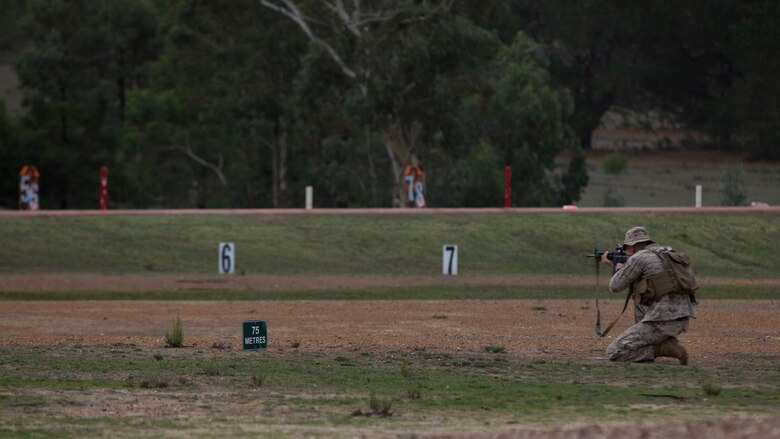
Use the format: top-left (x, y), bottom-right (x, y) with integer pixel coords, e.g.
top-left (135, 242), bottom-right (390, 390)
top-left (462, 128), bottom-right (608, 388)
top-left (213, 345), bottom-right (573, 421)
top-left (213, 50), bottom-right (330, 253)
top-left (607, 317), bottom-right (688, 361)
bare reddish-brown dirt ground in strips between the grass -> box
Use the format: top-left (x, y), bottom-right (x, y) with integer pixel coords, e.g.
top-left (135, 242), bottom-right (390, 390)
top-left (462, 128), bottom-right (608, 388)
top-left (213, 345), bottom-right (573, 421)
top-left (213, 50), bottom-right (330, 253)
top-left (0, 275), bottom-right (780, 439)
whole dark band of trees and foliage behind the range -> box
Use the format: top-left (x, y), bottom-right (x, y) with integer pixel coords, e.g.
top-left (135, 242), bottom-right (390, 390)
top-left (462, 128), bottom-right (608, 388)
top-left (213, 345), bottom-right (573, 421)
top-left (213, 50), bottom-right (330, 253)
top-left (0, 0), bottom-right (780, 208)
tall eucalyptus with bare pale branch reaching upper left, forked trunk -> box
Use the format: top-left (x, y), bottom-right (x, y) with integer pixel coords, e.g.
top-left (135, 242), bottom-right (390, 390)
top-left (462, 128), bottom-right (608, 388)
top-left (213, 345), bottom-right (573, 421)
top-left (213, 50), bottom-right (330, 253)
top-left (260, 0), bottom-right (494, 204)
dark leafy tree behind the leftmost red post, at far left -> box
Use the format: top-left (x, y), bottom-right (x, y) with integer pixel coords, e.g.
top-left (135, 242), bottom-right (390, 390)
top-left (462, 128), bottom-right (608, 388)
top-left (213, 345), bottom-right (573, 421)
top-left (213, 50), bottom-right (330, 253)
top-left (14, 0), bottom-right (156, 208)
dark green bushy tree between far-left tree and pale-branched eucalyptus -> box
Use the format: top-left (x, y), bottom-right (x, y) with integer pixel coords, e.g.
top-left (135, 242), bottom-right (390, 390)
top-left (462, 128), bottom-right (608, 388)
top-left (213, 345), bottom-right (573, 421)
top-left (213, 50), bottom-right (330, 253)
top-left (125, 1), bottom-right (303, 207)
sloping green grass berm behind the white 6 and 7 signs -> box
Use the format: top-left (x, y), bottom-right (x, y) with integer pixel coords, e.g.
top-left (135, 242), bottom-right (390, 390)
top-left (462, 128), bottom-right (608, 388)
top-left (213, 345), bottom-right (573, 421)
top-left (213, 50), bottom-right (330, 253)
top-left (0, 209), bottom-right (780, 279)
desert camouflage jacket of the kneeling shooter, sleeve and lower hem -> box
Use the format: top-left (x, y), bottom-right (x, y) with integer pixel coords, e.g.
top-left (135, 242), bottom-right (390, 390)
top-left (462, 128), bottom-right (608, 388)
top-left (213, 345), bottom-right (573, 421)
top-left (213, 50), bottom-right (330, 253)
top-left (609, 244), bottom-right (696, 322)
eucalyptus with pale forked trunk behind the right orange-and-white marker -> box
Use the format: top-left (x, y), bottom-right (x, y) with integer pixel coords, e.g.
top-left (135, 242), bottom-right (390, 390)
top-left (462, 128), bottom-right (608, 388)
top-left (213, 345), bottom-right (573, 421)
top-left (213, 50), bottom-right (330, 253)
top-left (260, 0), bottom-right (482, 204)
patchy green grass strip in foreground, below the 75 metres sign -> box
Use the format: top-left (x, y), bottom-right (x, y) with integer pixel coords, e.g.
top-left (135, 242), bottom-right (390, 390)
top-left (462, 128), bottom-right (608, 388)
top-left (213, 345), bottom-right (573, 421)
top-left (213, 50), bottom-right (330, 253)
top-left (0, 346), bottom-right (780, 436)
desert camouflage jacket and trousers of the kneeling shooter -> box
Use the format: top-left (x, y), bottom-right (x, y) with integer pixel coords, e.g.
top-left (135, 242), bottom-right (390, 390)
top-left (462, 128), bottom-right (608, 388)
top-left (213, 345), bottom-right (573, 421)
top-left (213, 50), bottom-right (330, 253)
top-left (606, 243), bottom-right (696, 361)
